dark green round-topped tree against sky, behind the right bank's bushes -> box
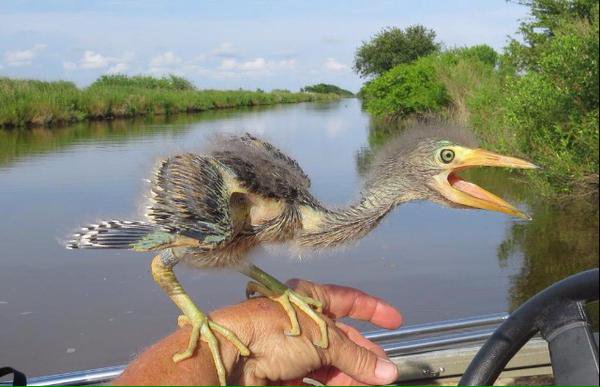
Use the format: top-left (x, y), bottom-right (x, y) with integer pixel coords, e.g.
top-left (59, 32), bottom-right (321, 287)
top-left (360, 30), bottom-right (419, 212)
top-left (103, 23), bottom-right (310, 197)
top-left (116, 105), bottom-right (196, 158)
top-left (354, 25), bottom-right (440, 77)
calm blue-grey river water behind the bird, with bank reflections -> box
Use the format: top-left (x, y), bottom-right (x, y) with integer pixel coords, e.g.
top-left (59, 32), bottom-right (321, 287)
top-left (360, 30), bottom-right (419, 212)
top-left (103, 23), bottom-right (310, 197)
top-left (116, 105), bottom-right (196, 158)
top-left (0, 100), bottom-right (598, 375)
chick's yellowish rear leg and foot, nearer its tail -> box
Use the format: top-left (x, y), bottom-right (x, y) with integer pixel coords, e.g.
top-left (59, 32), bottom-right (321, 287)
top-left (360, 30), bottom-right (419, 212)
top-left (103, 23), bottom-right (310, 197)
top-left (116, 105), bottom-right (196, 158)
top-left (151, 249), bottom-right (250, 386)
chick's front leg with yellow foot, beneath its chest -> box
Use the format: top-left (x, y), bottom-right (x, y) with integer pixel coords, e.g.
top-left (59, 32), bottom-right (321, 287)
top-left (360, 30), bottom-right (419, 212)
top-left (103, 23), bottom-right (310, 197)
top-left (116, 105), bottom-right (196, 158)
top-left (240, 265), bottom-right (329, 348)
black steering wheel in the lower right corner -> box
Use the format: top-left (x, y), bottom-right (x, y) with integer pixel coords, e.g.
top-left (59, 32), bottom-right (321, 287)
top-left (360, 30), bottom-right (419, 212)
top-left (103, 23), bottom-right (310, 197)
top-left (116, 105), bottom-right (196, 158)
top-left (459, 269), bottom-right (598, 386)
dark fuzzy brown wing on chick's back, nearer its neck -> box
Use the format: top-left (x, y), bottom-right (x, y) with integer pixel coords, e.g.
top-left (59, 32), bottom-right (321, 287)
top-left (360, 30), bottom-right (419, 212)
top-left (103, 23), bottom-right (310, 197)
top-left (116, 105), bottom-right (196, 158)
top-left (211, 133), bottom-right (312, 203)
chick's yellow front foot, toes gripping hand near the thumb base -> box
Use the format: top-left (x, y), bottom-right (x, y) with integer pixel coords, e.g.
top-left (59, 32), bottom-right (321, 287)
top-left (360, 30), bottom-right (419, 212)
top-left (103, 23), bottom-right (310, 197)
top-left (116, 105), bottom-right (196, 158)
top-left (246, 281), bottom-right (329, 348)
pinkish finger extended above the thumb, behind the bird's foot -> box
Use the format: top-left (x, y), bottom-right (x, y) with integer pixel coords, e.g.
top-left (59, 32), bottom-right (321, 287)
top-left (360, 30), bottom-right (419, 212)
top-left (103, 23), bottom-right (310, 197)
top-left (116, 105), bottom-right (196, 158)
top-left (288, 279), bottom-right (402, 329)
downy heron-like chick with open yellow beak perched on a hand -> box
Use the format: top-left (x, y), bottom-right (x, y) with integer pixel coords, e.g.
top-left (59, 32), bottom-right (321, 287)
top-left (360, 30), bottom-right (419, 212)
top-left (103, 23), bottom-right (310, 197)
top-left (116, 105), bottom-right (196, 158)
top-left (67, 124), bottom-right (537, 385)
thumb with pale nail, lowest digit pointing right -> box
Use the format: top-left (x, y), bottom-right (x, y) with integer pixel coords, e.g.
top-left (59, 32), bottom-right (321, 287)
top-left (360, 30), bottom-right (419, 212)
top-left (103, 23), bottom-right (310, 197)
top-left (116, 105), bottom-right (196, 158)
top-left (329, 328), bottom-right (398, 385)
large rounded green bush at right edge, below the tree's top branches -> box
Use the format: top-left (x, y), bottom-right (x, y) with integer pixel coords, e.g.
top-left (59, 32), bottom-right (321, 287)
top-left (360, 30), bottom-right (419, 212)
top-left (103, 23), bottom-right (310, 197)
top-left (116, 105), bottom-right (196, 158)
top-left (505, 19), bottom-right (599, 185)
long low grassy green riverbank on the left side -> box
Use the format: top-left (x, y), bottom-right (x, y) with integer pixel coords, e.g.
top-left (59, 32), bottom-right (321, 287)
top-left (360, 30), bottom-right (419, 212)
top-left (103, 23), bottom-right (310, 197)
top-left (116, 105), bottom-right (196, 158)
top-left (0, 75), bottom-right (341, 128)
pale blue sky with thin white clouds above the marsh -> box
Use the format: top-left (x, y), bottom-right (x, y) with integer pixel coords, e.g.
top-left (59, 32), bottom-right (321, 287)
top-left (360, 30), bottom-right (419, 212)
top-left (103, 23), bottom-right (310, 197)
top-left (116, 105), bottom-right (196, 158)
top-left (0, 0), bottom-right (527, 91)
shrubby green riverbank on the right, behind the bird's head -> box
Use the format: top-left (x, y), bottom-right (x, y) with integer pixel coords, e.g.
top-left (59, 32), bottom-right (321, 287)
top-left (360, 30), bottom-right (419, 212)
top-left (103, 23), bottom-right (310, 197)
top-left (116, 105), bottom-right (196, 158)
top-left (360, 45), bottom-right (598, 197)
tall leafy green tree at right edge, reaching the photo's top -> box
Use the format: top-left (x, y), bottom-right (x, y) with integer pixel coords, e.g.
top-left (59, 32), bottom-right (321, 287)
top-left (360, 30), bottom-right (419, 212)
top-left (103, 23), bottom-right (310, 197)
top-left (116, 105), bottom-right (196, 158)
top-left (503, 0), bottom-right (600, 192)
